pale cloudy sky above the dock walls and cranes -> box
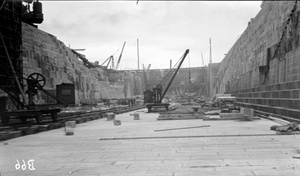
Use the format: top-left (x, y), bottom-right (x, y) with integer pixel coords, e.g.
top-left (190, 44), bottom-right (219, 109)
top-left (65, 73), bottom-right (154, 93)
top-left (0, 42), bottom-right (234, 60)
top-left (39, 1), bottom-right (261, 69)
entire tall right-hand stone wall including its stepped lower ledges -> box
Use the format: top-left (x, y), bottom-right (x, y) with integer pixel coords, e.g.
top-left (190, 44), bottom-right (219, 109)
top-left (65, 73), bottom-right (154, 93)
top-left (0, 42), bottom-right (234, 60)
top-left (216, 1), bottom-right (300, 117)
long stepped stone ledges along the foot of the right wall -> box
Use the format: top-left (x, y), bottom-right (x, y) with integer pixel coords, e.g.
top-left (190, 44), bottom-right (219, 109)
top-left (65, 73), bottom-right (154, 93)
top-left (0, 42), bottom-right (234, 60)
top-left (226, 80), bottom-right (300, 119)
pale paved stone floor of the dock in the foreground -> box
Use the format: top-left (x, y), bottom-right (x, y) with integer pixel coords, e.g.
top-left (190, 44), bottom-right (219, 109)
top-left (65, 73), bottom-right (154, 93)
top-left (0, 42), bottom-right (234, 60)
top-left (0, 110), bottom-right (300, 176)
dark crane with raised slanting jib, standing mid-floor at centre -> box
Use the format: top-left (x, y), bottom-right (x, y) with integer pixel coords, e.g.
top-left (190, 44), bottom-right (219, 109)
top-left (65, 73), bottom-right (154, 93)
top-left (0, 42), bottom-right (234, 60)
top-left (144, 49), bottom-right (190, 112)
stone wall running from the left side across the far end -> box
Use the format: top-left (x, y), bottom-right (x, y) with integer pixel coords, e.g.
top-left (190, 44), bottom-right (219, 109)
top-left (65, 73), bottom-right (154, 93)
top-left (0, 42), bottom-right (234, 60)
top-left (22, 23), bottom-right (207, 104)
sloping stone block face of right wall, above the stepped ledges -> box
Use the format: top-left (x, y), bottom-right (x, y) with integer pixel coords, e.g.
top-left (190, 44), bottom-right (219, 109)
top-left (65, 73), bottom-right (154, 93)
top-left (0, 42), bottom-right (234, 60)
top-left (219, 1), bottom-right (300, 92)
